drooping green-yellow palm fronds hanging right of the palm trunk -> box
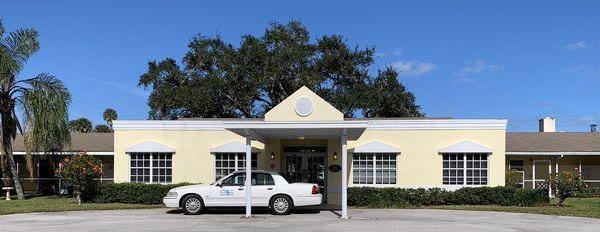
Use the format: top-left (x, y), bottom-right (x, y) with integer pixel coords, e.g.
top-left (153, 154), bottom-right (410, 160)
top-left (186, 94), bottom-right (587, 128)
top-left (18, 74), bottom-right (71, 157)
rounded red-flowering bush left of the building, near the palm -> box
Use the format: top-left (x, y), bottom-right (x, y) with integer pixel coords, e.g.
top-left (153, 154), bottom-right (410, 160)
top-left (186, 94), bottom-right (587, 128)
top-left (54, 152), bottom-right (102, 204)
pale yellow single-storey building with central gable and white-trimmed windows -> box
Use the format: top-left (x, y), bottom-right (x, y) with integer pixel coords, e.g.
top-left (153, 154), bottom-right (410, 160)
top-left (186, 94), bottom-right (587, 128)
top-left (114, 87), bottom-right (507, 205)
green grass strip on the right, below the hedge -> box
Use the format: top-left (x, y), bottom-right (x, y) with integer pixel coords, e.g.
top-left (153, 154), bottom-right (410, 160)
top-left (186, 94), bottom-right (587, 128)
top-left (422, 198), bottom-right (600, 218)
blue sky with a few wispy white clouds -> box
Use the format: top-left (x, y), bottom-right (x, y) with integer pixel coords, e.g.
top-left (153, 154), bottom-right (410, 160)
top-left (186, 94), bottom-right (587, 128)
top-left (0, 0), bottom-right (600, 131)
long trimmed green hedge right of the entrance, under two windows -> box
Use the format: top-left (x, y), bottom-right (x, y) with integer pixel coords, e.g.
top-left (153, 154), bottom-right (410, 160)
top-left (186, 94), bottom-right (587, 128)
top-left (348, 187), bottom-right (549, 208)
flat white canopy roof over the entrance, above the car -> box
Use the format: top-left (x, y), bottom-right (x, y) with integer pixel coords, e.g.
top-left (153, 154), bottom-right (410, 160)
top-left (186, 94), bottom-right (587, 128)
top-left (223, 120), bottom-right (369, 142)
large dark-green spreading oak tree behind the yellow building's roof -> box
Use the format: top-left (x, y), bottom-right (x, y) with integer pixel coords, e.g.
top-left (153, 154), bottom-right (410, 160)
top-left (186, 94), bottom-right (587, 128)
top-left (139, 21), bottom-right (423, 119)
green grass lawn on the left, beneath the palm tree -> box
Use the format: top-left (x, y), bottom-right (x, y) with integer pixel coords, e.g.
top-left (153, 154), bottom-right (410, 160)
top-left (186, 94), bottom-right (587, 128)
top-left (0, 196), bottom-right (162, 215)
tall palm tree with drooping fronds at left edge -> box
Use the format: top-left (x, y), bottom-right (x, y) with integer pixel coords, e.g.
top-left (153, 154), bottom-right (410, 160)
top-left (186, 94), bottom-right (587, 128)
top-left (0, 21), bottom-right (71, 200)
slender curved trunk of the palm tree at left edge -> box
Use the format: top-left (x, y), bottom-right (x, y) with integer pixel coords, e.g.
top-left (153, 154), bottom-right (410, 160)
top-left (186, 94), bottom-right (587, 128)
top-left (2, 112), bottom-right (25, 200)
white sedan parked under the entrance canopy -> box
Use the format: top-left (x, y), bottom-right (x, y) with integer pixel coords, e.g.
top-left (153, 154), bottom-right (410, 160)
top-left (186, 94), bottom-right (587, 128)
top-left (163, 170), bottom-right (323, 215)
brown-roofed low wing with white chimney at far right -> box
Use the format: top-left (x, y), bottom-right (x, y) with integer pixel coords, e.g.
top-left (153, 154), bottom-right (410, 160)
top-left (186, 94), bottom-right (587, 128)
top-left (506, 117), bottom-right (600, 189)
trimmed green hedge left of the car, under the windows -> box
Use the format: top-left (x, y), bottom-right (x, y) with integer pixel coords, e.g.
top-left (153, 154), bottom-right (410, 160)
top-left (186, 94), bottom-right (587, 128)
top-left (93, 183), bottom-right (195, 205)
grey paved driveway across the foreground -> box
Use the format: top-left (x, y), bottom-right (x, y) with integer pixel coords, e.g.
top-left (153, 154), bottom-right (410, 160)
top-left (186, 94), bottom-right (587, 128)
top-left (0, 209), bottom-right (600, 231)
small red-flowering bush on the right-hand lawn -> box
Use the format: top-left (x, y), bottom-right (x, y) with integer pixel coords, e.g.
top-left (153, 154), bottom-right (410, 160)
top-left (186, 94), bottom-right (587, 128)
top-left (550, 168), bottom-right (588, 206)
